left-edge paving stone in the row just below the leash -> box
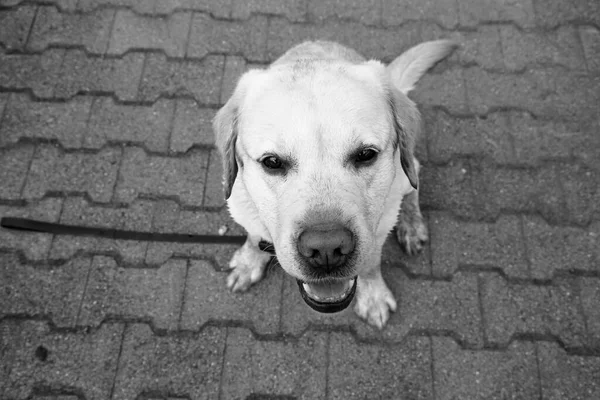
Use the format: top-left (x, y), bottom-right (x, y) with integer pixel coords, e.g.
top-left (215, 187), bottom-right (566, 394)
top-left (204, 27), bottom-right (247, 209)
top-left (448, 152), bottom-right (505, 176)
top-left (0, 254), bottom-right (91, 327)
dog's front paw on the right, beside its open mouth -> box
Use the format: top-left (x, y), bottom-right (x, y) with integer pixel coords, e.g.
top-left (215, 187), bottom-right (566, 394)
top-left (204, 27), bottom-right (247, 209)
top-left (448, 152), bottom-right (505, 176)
top-left (354, 273), bottom-right (397, 329)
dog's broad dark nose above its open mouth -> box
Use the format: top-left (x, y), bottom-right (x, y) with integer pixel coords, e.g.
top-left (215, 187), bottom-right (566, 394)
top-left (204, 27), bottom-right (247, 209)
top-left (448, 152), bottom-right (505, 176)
top-left (298, 225), bottom-right (354, 269)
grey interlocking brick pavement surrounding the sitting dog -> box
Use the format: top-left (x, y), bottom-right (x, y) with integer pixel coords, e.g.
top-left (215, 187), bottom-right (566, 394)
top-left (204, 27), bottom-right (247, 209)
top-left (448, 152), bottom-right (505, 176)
top-left (0, 0), bottom-right (600, 400)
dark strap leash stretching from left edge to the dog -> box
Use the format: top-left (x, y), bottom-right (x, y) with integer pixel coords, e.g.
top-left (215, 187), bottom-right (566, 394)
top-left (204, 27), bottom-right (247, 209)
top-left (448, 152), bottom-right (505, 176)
top-left (0, 217), bottom-right (275, 255)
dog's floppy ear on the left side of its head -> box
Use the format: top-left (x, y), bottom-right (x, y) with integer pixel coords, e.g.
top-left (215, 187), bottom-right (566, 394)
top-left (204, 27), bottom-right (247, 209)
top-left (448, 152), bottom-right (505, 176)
top-left (213, 70), bottom-right (260, 199)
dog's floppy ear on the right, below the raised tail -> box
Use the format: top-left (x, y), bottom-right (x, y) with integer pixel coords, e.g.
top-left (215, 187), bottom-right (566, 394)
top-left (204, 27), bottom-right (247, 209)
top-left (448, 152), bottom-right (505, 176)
top-left (388, 88), bottom-right (421, 189)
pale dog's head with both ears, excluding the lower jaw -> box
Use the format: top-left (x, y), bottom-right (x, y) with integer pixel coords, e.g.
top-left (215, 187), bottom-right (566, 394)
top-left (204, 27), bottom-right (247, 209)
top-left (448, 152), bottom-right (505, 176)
top-left (215, 61), bottom-right (418, 310)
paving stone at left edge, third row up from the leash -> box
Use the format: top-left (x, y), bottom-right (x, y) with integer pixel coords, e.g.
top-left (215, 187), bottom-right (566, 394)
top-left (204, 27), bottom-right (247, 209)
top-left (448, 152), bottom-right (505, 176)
top-left (0, 49), bottom-right (65, 98)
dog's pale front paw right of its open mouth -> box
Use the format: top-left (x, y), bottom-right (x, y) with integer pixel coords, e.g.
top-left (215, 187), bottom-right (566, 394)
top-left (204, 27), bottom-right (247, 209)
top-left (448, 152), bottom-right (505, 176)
top-left (354, 284), bottom-right (397, 329)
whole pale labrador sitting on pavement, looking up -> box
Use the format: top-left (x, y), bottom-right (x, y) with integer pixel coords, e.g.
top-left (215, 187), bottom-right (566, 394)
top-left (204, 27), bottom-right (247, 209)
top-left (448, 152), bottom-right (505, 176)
top-left (213, 40), bottom-right (455, 329)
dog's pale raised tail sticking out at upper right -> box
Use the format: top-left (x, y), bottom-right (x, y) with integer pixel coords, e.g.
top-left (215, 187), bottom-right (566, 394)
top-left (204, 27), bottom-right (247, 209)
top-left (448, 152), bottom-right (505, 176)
top-left (387, 40), bottom-right (458, 94)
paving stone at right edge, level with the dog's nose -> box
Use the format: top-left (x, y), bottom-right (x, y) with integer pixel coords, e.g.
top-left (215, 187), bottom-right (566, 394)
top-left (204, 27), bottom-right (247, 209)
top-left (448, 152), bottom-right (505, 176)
top-left (523, 217), bottom-right (600, 279)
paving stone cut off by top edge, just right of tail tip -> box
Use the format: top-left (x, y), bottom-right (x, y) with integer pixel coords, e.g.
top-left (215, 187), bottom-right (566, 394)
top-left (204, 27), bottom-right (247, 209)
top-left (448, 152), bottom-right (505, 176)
top-left (458, 0), bottom-right (535, 28)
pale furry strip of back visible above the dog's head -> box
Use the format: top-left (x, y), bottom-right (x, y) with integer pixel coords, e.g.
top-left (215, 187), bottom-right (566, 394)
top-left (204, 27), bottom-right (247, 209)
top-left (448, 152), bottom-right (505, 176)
top-left (272, 40), bottom-right (366, 65)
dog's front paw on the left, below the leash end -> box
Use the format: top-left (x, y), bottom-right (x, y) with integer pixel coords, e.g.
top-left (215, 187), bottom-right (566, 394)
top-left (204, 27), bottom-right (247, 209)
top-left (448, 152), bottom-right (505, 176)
top-left (227, 235), bottom-right (271, 292)
